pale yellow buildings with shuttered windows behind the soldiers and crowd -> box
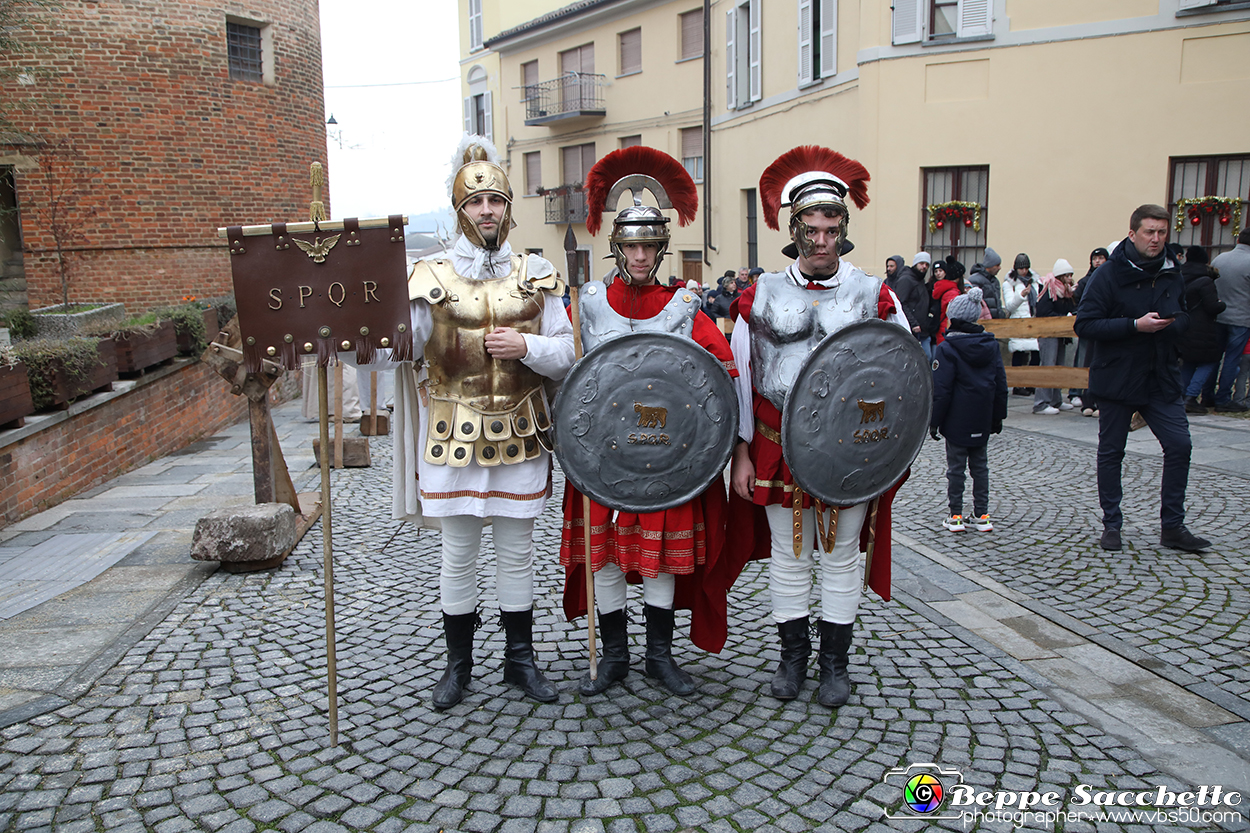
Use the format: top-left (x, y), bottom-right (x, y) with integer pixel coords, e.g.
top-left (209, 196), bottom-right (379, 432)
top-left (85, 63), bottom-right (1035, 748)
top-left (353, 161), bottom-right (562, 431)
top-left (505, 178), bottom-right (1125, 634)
top-left (459, 0), bottom-right (1250, 285)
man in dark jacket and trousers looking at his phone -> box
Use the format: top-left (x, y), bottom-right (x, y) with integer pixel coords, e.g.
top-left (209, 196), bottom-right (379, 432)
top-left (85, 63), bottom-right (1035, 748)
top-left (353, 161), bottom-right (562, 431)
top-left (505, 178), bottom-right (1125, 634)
top-left (1075, 205), bottom-right (1210, 553)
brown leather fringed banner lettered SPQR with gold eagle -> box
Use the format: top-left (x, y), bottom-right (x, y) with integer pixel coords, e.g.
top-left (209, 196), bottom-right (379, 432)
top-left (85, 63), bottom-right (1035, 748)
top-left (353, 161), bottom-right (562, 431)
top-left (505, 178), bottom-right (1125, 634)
top-left (226, 214), bottom-right (413, 373)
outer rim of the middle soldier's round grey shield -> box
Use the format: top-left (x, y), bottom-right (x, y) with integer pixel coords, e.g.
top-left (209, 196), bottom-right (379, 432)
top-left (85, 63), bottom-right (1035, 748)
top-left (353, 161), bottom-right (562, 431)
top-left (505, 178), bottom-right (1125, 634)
top-left (551, 331), bottom-right (738, 513)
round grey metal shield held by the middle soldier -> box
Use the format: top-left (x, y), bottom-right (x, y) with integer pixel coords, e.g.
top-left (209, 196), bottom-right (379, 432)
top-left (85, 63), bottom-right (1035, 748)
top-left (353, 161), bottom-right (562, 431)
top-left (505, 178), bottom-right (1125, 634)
top-left (551, 333), bottom-right (738, 512)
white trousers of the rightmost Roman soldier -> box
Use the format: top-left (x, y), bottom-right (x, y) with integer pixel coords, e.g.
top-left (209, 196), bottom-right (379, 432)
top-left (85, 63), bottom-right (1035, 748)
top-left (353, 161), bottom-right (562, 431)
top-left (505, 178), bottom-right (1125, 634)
top-left (764, 503), bottom-right (868, 624)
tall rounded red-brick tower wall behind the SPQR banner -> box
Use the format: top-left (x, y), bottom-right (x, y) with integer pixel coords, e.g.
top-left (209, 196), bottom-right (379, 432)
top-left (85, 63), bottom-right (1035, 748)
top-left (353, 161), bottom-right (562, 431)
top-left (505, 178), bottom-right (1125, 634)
top-left (0, 0), bottom-right (329, 313)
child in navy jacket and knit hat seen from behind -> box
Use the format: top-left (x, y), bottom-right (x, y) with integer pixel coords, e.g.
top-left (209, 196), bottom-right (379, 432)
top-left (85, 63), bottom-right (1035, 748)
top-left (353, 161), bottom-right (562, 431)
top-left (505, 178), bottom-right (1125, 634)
top-left (929, 286), bottom-right (1008, 532)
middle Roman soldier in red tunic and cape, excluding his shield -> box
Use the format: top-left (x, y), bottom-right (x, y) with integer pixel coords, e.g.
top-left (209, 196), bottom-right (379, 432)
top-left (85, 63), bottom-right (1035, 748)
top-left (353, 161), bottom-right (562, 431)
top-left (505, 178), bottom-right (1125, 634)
top-left (558, 146), bottom-right (736, 695)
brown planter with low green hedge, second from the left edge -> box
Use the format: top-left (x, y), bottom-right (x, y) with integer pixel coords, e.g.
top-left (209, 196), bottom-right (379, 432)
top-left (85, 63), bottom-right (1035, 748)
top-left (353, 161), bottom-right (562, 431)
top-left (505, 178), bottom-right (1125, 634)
top-left (14, 339), bottom-right (118, 410)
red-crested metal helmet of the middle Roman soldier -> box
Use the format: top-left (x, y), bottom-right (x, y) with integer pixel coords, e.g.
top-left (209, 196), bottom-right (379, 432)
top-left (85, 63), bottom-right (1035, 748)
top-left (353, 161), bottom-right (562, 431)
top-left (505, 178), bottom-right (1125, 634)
top-left (586, 145), bottom-right (699, 284)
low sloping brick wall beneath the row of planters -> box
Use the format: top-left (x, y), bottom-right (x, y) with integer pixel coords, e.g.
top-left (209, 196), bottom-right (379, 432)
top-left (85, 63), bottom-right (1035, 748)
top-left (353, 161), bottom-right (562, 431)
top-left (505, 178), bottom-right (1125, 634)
top-left (0, 361), bottom-right (300, 529)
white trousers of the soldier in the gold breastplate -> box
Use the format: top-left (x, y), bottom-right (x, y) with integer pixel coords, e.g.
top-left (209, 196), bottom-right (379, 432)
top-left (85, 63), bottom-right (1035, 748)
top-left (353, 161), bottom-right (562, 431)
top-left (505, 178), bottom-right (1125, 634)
top-left (439, 515), bottom-right (534, 617)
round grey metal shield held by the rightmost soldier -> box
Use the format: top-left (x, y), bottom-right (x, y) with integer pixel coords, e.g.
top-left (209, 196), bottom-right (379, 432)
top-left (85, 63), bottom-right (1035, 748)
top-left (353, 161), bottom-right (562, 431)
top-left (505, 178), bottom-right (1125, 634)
top-left (781, 319), bottom-right (934, 507)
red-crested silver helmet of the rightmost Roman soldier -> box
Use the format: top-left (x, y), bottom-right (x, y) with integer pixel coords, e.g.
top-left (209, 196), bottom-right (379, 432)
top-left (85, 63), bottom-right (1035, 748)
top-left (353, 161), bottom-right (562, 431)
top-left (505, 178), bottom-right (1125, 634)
top-left (760, 145), bottom-right (871, 258)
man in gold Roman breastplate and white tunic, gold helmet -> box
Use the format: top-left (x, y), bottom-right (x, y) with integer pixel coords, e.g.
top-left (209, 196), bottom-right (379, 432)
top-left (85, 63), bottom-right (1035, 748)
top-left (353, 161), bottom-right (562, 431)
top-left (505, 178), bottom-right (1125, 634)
top-left (393, 135), bottom-right (574, 709)
